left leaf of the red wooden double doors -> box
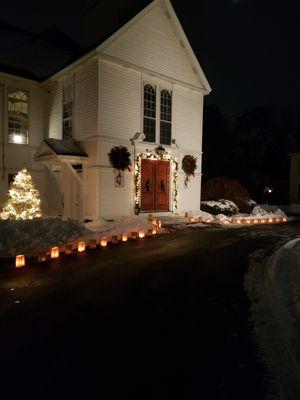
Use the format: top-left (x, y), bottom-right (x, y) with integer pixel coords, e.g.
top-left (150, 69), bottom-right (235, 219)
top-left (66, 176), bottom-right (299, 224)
top-left (141, 160), bottom-right (155, 211)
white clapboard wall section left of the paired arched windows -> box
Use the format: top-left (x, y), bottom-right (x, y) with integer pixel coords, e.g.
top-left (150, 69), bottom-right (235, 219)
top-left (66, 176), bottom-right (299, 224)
top-left (100, 61), bottom-right (141, 140)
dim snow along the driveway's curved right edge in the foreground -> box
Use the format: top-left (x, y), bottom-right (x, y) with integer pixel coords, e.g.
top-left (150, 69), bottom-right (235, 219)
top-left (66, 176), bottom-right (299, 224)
top-left (246, 238), bottom-right (300, 399)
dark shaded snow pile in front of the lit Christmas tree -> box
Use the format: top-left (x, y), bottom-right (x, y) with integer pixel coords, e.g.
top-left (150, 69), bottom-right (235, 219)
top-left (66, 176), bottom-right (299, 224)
top-left (0, 218), bottom-right (89, 258)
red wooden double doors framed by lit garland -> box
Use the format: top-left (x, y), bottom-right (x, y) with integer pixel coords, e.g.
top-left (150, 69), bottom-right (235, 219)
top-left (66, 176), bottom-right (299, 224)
top-left (141, 160), bottom-right (170, 211)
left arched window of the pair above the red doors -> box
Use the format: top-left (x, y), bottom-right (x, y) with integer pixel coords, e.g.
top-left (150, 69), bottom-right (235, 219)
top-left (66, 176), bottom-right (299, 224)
top-left (144, 84), bottom-right (156, 142)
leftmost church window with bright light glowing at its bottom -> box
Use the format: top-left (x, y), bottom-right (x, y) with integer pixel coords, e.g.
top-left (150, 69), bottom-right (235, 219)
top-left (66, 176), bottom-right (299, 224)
top-left (7, 88), bottom-right (29, 144)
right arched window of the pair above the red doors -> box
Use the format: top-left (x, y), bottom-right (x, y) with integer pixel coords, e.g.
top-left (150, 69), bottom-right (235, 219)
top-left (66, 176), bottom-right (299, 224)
top-left (160, 89), bottom-right (172, 145)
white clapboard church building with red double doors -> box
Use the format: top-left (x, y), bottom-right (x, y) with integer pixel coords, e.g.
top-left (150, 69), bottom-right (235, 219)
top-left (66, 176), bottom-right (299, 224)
top-left (0, 0), bottom-right (211, 219)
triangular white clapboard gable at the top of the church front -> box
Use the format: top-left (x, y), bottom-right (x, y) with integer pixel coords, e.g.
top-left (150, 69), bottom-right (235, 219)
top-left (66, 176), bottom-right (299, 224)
top-left (103, 4), bottom-right (203, 87)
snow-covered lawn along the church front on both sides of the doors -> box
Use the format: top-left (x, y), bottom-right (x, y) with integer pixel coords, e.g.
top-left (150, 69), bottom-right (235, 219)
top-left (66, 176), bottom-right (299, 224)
top-left (0, 207), bottom-right (285, 258)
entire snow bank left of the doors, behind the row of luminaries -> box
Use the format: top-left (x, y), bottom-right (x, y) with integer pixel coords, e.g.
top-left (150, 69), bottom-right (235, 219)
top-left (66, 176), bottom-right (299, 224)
top-left (0, 215), bottom-right (154, 258)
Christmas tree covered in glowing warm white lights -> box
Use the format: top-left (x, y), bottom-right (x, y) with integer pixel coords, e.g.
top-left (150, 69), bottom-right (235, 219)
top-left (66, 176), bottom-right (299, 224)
top-left (1, 168), bottom-right (42, 219)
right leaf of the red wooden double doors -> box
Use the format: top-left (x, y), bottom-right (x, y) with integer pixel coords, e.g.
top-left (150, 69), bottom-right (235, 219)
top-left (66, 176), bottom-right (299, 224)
top-left (155, 161), bottom-right (170, 211)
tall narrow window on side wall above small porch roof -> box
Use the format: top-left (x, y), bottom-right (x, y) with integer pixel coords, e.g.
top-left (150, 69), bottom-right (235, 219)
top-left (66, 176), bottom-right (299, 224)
top-left (62, 76), bottom-right (74, 139)
